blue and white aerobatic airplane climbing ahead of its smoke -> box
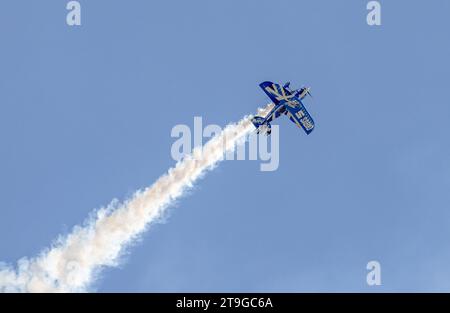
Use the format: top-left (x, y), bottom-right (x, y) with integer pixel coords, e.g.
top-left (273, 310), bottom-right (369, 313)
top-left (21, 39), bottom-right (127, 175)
top-left (252, 81), bottom-right (315, 136)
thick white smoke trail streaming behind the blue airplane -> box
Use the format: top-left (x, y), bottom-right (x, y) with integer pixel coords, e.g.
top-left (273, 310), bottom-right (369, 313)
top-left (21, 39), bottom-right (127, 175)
top-left (0, 105), bottom-right (271, 292)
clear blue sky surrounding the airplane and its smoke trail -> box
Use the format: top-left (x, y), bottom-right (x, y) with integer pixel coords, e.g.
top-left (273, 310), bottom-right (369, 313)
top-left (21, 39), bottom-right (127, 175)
top-left (0, 0), bottom-right (450, 292)
